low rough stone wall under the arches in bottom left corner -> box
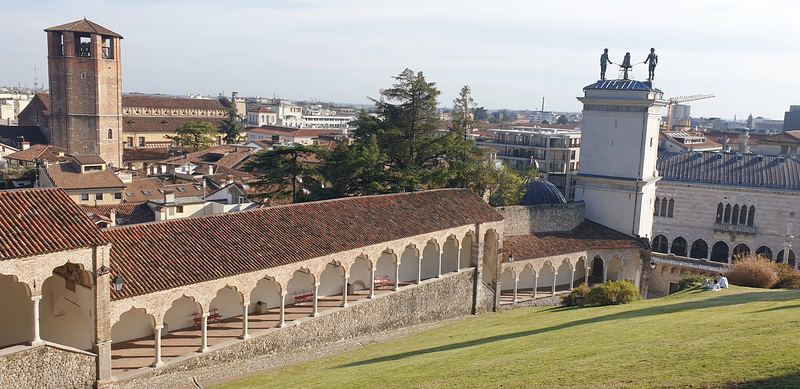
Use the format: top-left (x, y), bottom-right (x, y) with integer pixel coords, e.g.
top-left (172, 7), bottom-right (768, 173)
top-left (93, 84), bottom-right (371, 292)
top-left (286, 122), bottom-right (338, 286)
top-left (0, 345), bottom-right (95, 389)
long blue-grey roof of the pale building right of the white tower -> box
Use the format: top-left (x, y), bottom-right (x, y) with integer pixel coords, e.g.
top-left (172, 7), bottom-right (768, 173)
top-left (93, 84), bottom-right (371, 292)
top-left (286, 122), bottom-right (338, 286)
top-left (656, 152), bottom-right (800, 190)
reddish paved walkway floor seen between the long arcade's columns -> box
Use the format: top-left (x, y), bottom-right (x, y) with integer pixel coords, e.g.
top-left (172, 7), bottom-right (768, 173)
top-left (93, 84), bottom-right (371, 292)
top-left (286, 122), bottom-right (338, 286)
top-left (111, 282), bottom-right (400, 375)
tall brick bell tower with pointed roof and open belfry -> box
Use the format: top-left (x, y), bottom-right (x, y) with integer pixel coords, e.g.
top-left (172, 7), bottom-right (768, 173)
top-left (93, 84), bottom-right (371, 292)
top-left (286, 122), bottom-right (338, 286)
top-left (45, 19), bottom-right (122, 167)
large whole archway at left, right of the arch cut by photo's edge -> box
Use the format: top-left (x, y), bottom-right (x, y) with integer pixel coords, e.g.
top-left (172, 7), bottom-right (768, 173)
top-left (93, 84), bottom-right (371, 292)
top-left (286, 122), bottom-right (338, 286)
top-left (39, 262), bottom-right (94, 350)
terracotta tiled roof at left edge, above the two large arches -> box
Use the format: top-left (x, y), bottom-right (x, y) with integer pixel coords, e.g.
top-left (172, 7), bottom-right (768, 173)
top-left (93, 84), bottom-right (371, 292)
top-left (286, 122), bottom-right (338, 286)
top-left (0, 188), bottom-right (108, 260)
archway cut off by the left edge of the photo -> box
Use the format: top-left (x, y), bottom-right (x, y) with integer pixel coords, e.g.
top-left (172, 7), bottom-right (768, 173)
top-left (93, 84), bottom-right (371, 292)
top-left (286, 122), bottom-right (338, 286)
top-left (0, 274), bottom-right (33, 348)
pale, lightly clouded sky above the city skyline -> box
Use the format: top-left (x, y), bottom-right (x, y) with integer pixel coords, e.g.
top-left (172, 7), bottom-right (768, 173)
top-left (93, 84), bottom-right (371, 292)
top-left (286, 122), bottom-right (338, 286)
top-left (0, 0), bottom-right (800, 121)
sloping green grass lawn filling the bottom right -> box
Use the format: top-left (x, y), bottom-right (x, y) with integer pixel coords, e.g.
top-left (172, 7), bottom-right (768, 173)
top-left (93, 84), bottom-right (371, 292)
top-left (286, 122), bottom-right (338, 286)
top-left (212, 287), bottom-right (800, 388)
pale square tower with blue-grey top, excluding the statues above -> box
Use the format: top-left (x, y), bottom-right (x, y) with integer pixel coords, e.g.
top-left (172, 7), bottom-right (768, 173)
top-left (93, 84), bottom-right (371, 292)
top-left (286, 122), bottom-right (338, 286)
top-left (575, 80), bottom-right (667, 238)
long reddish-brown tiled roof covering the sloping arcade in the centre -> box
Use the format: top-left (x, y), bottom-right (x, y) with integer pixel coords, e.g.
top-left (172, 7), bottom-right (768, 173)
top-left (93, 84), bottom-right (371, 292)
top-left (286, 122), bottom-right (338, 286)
top-left (104, 189), bottom-right (503, 300)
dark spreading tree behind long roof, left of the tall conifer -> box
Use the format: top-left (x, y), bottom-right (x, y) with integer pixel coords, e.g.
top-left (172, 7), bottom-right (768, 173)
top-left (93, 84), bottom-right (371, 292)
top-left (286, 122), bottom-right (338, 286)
top-left (244, 144), bottom-right (325, 203)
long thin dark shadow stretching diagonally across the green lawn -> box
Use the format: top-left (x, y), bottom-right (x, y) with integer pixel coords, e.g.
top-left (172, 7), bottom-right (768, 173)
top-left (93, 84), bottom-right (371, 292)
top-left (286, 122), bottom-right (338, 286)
top-left (339, 290), bottom-right (798, 367)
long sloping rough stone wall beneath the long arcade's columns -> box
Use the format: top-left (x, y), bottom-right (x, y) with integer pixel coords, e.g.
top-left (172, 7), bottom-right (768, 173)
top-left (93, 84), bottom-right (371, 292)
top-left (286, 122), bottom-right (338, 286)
top-left (114, 269), bottom-right (484, 388)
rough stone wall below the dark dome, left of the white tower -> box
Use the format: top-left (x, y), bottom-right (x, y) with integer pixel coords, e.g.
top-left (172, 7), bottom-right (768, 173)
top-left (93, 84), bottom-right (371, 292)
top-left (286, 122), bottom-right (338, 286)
top-left (495, 201), bottom-right (586, 235)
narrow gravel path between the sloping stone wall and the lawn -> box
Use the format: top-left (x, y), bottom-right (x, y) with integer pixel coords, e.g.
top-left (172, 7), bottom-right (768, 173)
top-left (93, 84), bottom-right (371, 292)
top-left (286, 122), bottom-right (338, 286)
top-left (178, 316), bottom-right (469, 388)
